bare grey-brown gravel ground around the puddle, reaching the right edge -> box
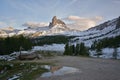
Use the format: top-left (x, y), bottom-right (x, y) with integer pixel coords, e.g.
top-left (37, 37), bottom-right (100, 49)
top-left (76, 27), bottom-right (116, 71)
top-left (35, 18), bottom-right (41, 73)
top-left (36, 56), bottom-right (120, 80)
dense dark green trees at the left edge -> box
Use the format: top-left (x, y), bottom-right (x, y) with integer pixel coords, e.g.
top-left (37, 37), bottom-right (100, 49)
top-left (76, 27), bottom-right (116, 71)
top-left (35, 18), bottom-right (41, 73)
top-left (0, 35), bottom-right (33, 55)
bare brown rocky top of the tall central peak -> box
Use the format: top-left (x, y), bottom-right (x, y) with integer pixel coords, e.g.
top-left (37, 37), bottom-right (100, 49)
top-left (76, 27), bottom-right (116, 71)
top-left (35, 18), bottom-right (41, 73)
top-left (49, 16), bottom-right (66, 28)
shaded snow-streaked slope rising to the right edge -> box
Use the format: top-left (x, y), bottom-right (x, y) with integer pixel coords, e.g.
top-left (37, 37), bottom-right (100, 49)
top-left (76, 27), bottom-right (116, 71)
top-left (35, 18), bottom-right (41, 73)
top-left (68, 17), bottom-right (120, 46)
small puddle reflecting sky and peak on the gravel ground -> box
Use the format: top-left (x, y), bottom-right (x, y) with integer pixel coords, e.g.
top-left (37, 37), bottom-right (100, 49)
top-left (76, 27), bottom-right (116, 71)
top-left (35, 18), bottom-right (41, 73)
top-left (41, 65), bottom-right (79, 77)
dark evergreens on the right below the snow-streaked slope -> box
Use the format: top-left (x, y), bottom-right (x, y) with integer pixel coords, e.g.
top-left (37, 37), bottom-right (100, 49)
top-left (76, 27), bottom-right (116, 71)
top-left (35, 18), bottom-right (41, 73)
top-left (90, 35), bottom-right (120, 59)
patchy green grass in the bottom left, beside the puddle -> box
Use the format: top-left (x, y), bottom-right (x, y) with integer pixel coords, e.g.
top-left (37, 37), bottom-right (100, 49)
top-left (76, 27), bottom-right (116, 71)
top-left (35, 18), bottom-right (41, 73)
top-left (0, 61), bottom-right (48, 80)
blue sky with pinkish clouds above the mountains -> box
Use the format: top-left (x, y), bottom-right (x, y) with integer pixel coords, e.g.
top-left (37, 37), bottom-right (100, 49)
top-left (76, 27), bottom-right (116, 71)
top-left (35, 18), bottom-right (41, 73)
top-left (0, 0), bottom-right (120, 30)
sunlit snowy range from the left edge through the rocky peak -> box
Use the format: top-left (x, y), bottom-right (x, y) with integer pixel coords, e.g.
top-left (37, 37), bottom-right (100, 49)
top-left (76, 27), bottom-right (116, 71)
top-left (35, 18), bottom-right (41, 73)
top-left (0, 16), bottom-right (75, 37)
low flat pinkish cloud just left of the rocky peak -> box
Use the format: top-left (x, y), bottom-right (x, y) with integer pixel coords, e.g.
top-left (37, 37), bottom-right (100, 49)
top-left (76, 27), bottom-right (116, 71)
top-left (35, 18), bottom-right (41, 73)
top-left (23, 22), bottom-right (49, 28)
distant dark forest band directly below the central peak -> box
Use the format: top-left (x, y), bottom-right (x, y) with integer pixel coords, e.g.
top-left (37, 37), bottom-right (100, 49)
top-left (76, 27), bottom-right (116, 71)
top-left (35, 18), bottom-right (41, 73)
top-left (32, 35), bottom-right (75, 46)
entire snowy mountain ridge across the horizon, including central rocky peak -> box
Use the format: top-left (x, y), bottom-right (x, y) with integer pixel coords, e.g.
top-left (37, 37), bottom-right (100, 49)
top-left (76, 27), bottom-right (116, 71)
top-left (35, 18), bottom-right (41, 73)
top-left (0, 16), bottom-right (120, 40)
